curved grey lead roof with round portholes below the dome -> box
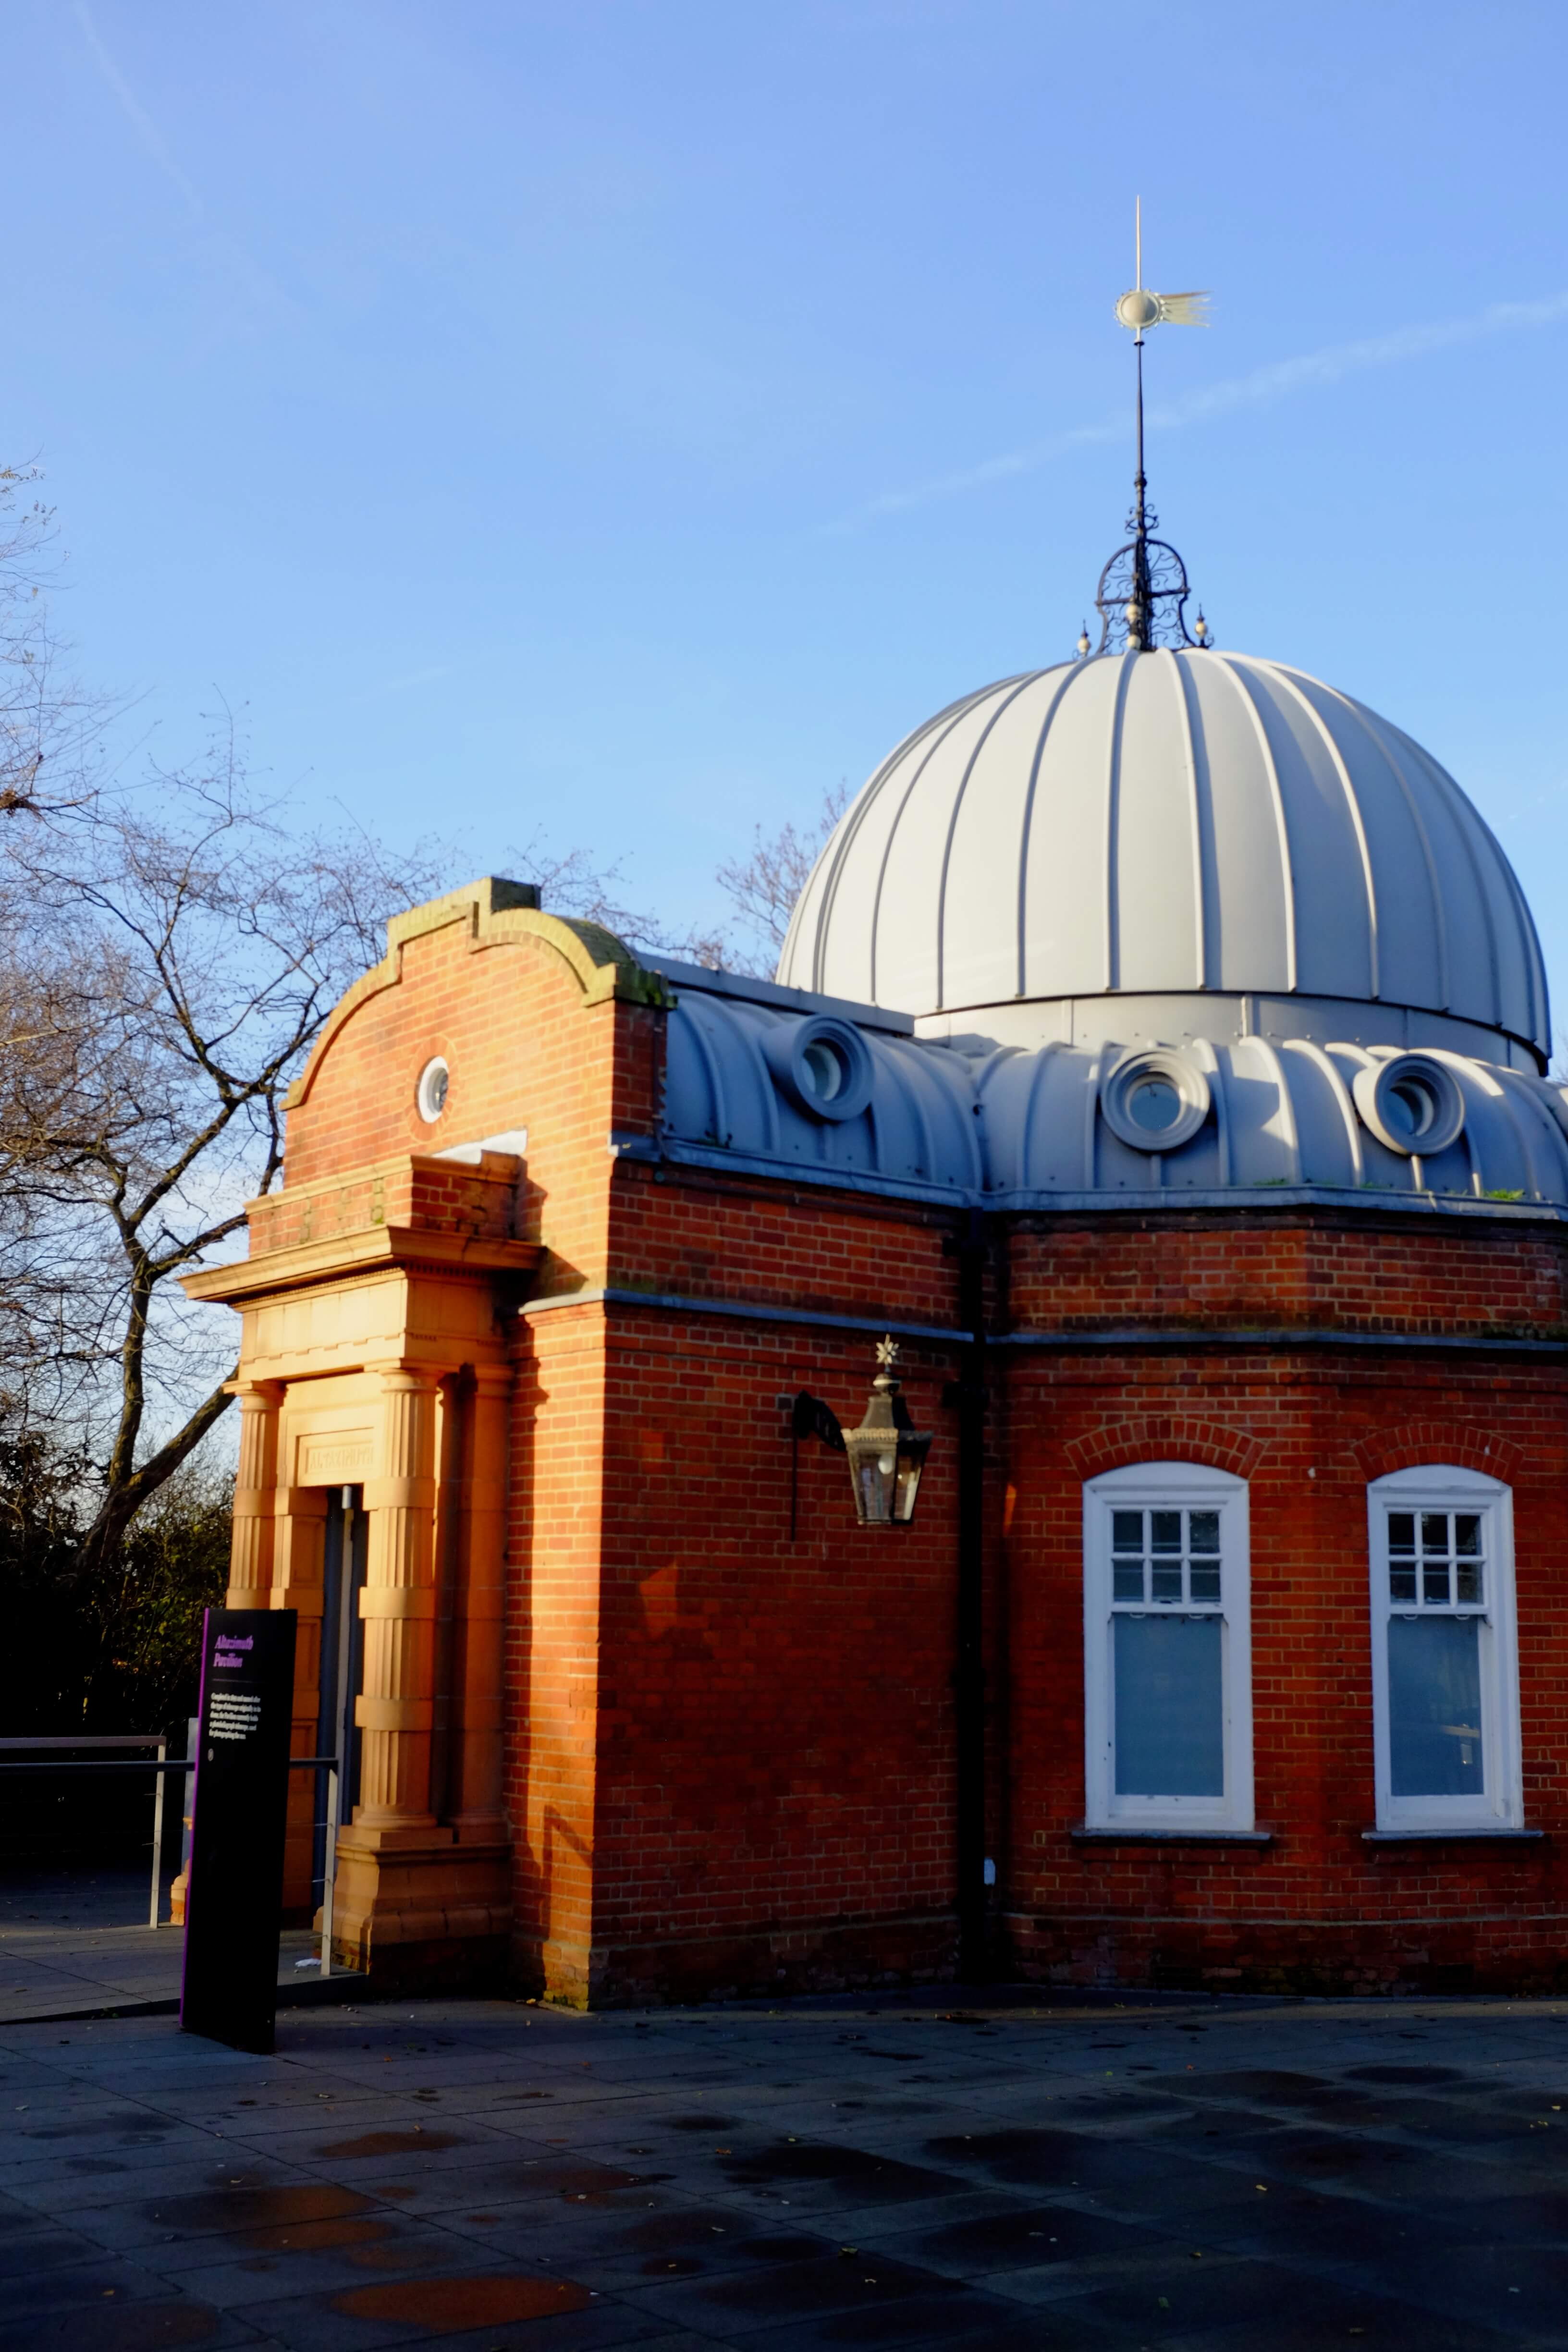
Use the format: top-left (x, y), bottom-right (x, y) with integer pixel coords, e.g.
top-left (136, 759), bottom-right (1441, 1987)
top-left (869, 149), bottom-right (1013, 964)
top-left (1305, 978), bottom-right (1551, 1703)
top-left (656, 967), bottom-right (1568, 1211)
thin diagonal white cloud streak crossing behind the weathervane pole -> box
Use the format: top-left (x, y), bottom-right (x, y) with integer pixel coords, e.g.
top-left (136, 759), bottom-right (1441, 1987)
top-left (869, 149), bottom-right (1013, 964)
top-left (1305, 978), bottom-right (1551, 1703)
top-left (846, 294), bottom-right (1568, 522)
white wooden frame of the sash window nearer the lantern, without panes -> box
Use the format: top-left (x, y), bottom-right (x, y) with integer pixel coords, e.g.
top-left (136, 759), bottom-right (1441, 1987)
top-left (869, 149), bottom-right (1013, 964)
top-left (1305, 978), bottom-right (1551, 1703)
top-left (1084, 1463), bottom-right (1253, 1835)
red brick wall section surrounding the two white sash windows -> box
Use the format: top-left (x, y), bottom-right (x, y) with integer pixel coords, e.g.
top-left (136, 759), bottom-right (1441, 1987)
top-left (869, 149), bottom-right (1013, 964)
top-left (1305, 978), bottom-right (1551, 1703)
top-left (1004, 1213), bottom-right (1568, 1990)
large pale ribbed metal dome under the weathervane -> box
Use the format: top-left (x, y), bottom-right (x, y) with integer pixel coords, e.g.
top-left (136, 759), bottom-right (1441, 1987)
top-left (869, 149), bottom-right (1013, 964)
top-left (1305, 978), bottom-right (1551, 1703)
top-left (778, 649), bottom-right (1549, 1058)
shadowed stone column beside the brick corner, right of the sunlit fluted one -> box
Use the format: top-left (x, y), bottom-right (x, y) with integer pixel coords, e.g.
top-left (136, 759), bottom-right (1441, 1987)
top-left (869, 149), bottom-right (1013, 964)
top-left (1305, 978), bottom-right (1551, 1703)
top-left (442, 1364), bottom-right (513, 1846)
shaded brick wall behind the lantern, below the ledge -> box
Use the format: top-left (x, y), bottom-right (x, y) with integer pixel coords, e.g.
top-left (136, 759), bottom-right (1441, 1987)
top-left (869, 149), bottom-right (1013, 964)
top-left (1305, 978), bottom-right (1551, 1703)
top-left (595, 1310), bottom-right (955, 1992)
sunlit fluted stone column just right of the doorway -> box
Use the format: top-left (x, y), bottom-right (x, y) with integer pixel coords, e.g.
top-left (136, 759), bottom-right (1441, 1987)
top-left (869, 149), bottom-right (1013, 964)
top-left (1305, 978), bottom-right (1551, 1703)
top-left (355, 1369), bottom-right (437, 1844)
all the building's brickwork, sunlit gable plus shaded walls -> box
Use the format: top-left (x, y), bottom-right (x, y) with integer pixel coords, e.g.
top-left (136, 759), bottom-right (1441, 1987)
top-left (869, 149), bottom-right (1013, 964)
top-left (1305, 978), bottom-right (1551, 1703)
top-left (263, 924), bottom-right (1568, 1999)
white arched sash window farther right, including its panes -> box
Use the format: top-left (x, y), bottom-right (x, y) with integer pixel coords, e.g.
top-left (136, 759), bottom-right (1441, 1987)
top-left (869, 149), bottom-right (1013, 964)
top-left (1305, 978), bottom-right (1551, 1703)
top-left (1368, 1463), bottom-right (1523, 1830)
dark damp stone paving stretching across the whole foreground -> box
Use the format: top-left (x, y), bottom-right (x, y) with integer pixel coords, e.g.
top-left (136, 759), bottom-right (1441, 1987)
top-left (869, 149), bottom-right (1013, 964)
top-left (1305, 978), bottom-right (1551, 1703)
top-left (0, 2001), bottom-right (1568, 2352)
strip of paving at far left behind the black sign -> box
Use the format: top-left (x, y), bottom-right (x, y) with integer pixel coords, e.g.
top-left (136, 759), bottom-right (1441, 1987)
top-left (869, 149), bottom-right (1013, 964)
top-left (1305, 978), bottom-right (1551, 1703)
top-left (0, 1863), bottom-right (355, 2032)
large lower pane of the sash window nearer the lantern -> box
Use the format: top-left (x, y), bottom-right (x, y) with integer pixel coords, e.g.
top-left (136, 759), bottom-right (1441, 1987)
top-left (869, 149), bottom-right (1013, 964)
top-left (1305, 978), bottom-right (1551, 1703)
top-left (1112, 1616), bottom-right (1225, 1797)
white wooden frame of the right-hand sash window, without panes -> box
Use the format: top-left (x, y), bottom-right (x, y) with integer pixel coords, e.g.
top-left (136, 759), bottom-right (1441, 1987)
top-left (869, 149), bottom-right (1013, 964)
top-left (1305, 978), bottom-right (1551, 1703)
top-left (1366, 1463), bottom-right (1523, 1832)
